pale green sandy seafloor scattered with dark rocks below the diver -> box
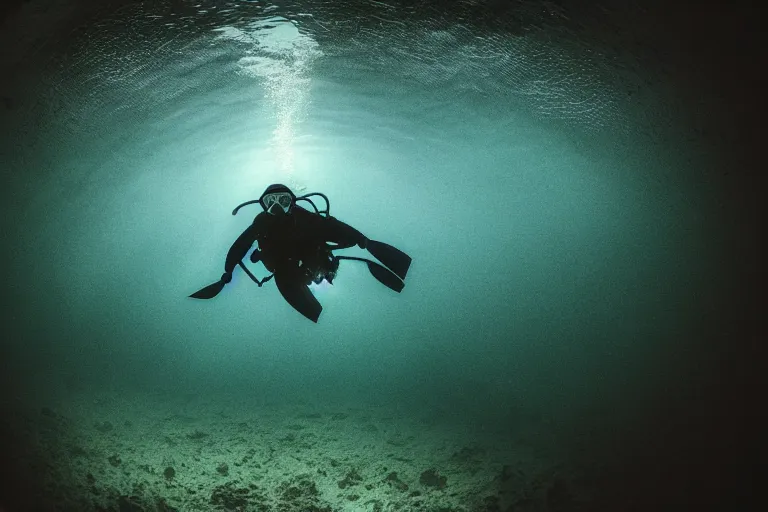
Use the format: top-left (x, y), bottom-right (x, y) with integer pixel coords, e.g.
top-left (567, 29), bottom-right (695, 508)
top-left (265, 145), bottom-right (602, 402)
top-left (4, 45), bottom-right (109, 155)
top-left (3, 393), bottom-right (583, 512)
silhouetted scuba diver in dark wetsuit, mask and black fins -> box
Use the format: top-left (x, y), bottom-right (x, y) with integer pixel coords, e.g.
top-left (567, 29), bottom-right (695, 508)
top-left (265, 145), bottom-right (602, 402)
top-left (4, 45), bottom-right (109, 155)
top-left (190, 183), bottom-right (411, 322)
